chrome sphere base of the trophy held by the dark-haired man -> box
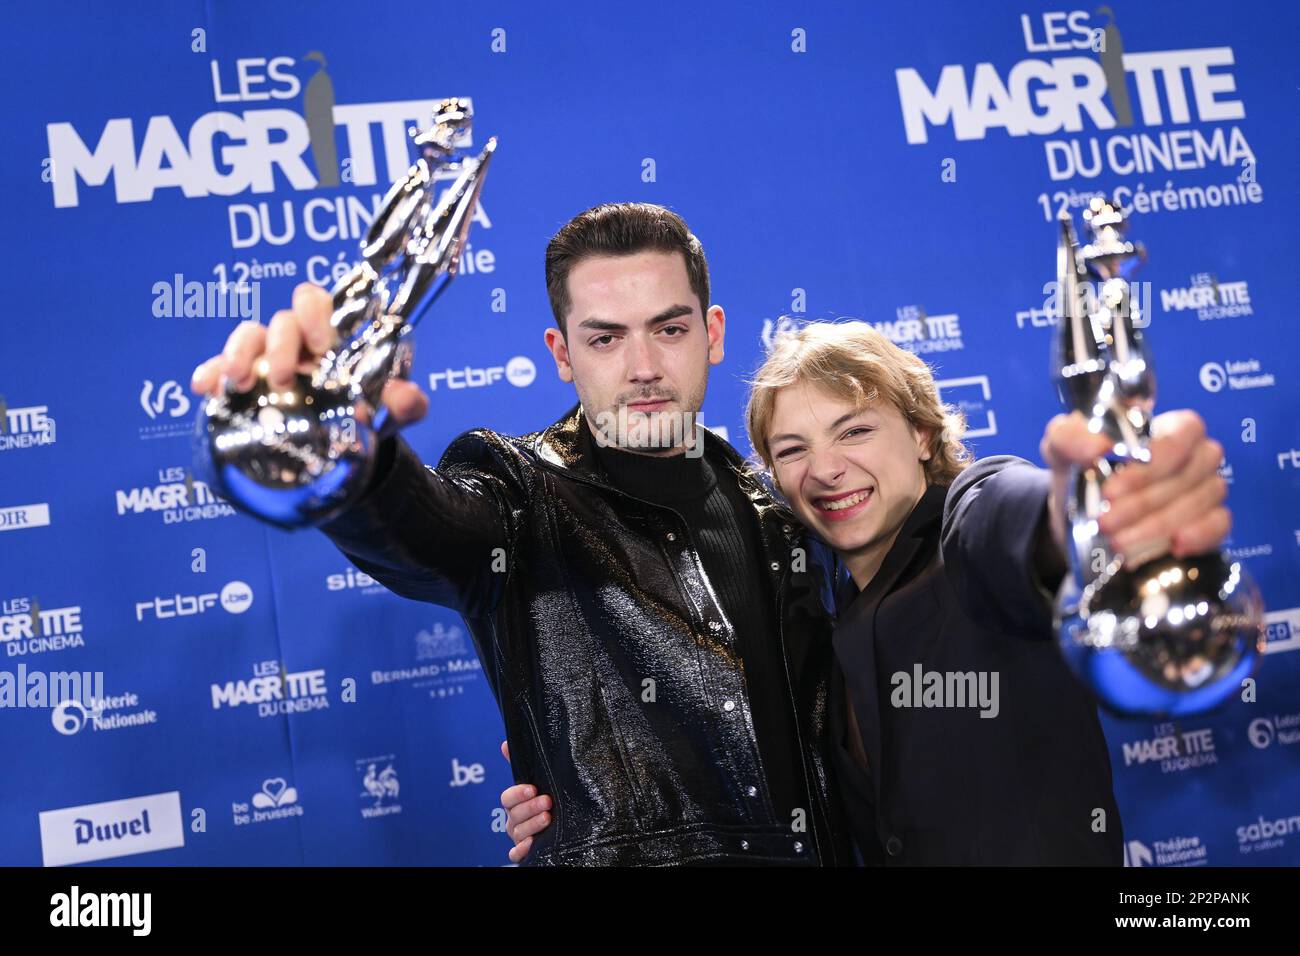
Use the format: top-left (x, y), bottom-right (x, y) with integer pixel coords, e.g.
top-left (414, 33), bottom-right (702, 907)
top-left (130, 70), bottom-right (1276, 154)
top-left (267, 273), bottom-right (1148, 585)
top-left (194, 373), bottom-right (384, 529)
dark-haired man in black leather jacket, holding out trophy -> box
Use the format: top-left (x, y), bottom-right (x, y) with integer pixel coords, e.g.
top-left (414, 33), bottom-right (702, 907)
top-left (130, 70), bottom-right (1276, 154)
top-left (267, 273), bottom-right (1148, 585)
top-left (194, 203), bottom-right (850, 865)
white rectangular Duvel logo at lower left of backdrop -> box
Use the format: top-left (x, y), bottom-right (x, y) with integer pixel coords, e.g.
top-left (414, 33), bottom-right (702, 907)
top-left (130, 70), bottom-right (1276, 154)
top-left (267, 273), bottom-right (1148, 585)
top-left (40, 791), bottom-right (185, 866)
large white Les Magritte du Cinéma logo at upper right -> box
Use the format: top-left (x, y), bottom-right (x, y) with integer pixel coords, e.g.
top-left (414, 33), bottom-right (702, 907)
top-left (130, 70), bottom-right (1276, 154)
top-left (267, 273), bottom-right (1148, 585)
top-left (894, 7), bottom-right (1262, 219)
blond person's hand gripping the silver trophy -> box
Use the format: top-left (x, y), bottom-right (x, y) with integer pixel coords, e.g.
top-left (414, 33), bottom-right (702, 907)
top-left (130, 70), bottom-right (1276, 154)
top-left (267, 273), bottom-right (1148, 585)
top-left (1040, 410), bottom-right (1232, 563)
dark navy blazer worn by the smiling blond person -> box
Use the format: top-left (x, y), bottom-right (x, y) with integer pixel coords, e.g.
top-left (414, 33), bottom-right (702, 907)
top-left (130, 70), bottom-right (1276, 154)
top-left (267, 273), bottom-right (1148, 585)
top-left (829, 455), bottom-right (1123, 866)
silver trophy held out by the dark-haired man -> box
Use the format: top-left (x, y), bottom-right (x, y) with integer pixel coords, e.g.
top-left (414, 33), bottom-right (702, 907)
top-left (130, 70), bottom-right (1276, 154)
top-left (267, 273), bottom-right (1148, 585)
top-left (194, 99), bottom-right (497, 528)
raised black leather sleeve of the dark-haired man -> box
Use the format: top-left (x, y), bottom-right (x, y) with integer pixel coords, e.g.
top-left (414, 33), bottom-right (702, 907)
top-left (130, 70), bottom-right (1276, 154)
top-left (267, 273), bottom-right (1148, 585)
top-left (320, 432), bottom-right (525, 615)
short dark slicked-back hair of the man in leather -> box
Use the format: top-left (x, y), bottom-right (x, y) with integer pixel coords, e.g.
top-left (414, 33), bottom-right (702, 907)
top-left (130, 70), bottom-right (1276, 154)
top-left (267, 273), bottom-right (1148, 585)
top-left (546, 203), bottom-right (709, 334)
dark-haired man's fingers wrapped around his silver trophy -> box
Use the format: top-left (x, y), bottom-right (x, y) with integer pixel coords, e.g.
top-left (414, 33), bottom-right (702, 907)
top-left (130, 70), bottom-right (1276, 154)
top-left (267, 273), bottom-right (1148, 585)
top-left (190, 282), bottom-right (429, 425)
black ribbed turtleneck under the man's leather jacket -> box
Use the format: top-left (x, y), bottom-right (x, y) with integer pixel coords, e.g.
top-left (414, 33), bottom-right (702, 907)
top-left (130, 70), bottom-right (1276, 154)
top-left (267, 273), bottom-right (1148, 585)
top-left (593, 442), bottom-right (809, 822)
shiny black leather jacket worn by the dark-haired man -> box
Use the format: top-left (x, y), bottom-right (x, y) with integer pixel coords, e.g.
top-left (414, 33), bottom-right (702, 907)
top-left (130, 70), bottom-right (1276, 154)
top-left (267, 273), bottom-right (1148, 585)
top-left (322, 406), bottom-right (850, 865)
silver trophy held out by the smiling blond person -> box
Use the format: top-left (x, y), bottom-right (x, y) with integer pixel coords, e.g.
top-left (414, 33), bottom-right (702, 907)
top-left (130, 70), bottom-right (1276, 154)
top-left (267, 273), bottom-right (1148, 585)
top-left (1053, 199), bottom-right (1265, 717)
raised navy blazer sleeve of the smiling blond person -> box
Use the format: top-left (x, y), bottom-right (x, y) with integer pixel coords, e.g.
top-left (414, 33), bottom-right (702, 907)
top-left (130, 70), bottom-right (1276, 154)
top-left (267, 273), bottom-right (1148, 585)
top-left (943, 455), bottom-right (1063, 639)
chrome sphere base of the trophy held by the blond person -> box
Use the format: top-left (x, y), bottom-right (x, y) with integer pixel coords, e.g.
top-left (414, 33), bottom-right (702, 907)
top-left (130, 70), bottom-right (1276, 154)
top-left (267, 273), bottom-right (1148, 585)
top-left (1056, 553), bottom-right (1265, 717)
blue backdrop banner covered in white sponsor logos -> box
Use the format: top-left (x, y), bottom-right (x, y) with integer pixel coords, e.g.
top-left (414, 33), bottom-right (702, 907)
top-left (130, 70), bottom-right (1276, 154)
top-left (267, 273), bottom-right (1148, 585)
top-left (0, 0), bottom-right (1300, 866)
